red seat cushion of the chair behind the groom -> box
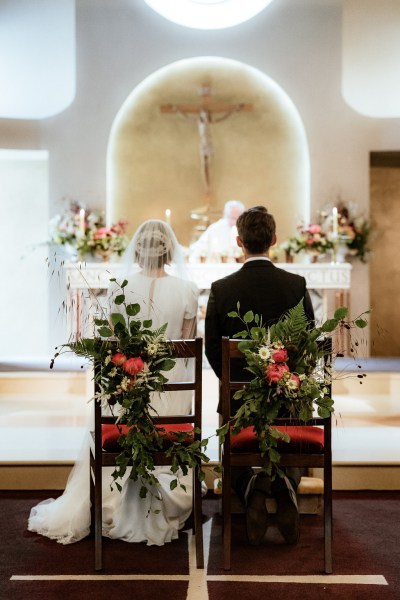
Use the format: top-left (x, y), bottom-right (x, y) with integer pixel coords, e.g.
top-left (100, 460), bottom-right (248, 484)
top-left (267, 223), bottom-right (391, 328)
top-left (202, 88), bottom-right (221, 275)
top-left (231, 425), bottom-right (324, 454)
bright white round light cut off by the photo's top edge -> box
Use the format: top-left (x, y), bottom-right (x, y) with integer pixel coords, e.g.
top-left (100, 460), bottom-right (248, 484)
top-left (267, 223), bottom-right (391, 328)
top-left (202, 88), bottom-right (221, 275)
top-left (145, 0), bottom-right (273, 29)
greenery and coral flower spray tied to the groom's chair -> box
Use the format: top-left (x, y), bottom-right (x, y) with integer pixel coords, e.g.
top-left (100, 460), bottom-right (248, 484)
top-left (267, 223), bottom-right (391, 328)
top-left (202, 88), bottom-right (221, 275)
top-left (217, 301), bottom-right (367, 476)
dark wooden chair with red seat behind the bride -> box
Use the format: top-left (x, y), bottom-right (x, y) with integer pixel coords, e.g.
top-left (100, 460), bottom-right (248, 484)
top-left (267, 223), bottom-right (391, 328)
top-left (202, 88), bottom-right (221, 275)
top-left (90, 338), bottom-right (204, 570)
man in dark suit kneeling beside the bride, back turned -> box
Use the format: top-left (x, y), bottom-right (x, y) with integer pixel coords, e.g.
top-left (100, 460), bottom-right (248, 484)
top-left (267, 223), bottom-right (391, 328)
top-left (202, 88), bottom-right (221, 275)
top-left (205, 206), bottom-right (314, 545)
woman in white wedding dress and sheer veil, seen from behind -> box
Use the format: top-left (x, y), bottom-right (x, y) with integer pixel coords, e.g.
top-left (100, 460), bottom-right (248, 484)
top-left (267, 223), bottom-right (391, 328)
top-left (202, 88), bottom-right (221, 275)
top-left (28, 220), bottom-right (198, 545)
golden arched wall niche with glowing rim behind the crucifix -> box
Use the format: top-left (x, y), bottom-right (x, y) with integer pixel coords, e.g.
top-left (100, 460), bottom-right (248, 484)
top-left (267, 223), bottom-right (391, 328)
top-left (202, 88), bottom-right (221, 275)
top-left (107, 57), bottom-right (310, 244)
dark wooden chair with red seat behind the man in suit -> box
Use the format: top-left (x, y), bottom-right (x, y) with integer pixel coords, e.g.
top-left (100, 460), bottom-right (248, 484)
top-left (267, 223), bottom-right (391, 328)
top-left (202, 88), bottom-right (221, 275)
top-left (220, 337), bottom-right (332, 573)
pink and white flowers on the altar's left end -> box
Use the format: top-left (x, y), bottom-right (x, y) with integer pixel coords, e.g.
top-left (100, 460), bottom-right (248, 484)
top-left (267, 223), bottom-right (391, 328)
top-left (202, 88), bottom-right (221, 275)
top-left (48, 201), bottom-right (129, 260)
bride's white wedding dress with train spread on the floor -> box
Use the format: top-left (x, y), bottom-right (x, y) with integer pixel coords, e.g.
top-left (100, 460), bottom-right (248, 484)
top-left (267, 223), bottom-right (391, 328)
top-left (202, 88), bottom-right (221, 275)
top-left (28, 273), bottom-right (198, 545)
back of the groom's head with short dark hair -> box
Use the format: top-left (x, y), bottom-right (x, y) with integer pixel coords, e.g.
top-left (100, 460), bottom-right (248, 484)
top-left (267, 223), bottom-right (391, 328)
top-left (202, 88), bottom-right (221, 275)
top-left (236, 206), bottom-right (276, 254)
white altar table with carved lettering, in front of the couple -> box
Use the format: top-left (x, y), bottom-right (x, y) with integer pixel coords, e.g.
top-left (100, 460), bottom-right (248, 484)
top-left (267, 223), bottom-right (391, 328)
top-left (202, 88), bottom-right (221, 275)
top-left (64, 262), bottom-right (352, 345)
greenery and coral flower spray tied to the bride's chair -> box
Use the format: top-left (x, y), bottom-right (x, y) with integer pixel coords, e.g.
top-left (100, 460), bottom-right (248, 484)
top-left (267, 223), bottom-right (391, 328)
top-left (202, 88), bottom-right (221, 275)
top-left (50, 278), bottom-right (209, 498)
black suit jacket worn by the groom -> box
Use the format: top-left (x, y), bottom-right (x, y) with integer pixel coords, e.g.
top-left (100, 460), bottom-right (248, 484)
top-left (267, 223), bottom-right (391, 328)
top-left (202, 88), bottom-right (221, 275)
top-left (205, 259), bottom-right (314, 378)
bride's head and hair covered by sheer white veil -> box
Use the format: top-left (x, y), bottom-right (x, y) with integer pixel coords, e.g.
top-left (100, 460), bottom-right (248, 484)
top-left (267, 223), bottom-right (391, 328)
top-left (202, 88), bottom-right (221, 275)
top-left (121, 219), bottom-right (188, 279)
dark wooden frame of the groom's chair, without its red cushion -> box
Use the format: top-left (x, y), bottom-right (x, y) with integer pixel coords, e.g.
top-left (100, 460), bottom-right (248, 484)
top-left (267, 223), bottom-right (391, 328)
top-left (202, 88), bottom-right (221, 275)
top-left (220, 337), bottom-right (332, 573)
